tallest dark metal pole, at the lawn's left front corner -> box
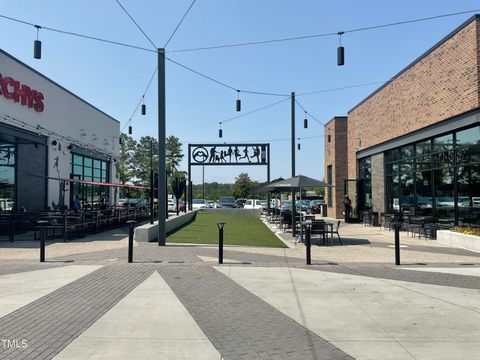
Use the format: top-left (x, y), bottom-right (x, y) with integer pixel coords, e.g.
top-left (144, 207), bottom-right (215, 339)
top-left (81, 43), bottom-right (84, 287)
top-left (157, 48), bottom-right (167, 246)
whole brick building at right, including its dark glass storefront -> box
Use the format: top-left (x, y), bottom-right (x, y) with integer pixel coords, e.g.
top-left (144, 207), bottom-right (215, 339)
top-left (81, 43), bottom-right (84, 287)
top-left (325, 15), bottom-right (480, 224)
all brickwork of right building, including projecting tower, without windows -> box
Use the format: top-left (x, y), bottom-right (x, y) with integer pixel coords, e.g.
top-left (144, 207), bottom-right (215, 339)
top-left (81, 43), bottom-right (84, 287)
top-left (325, 15), bottom-right (480, 217)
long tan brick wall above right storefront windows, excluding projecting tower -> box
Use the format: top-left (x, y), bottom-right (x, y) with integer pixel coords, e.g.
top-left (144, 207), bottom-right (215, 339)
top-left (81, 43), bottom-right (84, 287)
top-left (348, 17), bottom-right (480, 178)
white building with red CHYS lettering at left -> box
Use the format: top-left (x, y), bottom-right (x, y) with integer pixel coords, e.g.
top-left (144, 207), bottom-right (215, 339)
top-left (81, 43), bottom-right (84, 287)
top-left (0, 49), bottom-right (120, 211)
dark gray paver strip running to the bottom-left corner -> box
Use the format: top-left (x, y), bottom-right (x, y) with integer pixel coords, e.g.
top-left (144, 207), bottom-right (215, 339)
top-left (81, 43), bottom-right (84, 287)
top-left (0, 265), bottom-right (153, 360)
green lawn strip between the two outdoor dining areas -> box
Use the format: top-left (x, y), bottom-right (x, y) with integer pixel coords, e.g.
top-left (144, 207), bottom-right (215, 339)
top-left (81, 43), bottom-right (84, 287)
top-left (167, 211), bottom-right (286, 247)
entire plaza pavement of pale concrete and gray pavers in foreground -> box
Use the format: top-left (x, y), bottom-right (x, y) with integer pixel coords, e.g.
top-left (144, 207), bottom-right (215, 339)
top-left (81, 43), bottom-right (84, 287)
top-left (0, 219), bottom-right (480, 360)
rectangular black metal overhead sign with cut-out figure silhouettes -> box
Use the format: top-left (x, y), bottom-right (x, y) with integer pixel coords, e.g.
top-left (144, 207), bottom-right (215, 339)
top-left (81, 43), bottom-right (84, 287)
top-left (188, 144), bottom-right (270, 165)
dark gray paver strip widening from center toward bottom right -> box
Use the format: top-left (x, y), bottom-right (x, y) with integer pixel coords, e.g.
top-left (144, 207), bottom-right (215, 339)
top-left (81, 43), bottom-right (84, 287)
top-left (158, 266), bottom-right (352, 360)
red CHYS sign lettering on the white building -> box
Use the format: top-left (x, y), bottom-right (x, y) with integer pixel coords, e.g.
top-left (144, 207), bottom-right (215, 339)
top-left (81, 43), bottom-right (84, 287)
top-left (0, 74), bottom-right (45, 112)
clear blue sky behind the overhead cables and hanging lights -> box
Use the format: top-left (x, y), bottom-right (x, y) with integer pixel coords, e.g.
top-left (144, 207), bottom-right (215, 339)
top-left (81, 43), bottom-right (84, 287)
top-left (0, 0), bottom-right (480, 183)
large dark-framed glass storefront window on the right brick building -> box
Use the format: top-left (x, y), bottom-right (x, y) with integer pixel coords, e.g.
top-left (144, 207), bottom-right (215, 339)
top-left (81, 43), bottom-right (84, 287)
top-left (385, 126), bottom-right (480, 225)
